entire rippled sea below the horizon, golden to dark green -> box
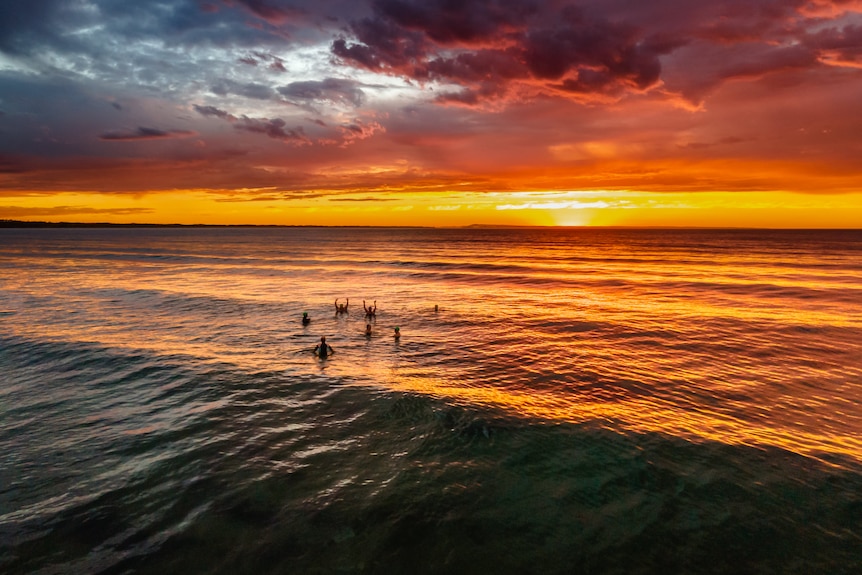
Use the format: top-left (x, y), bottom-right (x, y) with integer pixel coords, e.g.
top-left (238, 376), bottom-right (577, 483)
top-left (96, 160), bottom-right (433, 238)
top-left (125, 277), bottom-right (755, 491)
top-left (0, 227), bottom-right (862, 575)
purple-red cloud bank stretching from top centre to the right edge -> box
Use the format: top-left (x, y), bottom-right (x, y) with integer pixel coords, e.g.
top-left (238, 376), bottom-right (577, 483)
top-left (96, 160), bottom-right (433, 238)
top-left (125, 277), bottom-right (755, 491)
top-left (331, 0), bottom-right (862, 106)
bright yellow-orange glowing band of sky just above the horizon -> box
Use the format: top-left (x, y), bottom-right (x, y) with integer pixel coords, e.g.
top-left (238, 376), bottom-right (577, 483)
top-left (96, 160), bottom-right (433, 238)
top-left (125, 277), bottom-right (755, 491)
top-left (5, 189), bottom-right (862, 228)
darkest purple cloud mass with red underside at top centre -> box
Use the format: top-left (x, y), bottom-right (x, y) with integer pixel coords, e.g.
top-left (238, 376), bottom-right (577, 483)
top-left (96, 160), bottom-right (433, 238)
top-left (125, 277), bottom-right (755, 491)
top-left (332, 0), bottom-right (684, 104)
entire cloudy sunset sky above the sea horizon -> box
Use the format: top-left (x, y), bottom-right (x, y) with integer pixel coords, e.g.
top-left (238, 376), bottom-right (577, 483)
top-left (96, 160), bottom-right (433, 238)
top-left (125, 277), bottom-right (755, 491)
top-left (0, 0), bottom-right (862, 228)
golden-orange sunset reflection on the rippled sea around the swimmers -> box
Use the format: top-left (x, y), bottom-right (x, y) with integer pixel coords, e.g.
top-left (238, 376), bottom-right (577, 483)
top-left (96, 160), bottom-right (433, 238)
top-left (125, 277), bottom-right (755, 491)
top-left (6, 225), bottom-right (862, 472)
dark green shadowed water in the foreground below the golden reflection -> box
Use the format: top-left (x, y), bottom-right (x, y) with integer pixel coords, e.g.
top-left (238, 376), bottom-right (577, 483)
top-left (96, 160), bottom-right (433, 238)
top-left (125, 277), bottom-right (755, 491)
top-left (0, 387), bottom-right (862, 574)
